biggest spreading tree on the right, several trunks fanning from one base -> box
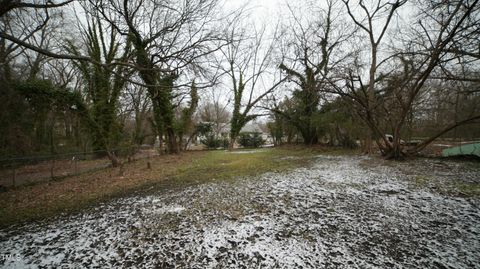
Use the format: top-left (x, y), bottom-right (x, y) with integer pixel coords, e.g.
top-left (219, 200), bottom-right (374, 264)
top-left (338, 1), bottom-right (478, 158)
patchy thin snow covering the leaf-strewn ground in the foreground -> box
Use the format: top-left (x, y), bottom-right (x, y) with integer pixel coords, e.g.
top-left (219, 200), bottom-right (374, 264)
top-left (0, 156), bottom-right (480, 268)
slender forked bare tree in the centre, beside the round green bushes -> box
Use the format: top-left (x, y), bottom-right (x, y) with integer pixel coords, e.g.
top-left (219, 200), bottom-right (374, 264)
top-left (219, 17), bottom-right (286, 149)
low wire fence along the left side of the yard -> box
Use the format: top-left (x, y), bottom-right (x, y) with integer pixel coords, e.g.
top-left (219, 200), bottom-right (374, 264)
top-left (0, 147), bottom-right (159, 187)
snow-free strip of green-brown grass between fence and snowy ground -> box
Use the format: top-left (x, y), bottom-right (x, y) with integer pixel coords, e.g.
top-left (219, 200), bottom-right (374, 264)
top-left (0, 147), bottom-right (341, 227)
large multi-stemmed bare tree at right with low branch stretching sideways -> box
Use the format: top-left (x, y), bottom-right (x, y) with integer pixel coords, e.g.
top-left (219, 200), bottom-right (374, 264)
top-left (331, 0), bottom-right (480, 158)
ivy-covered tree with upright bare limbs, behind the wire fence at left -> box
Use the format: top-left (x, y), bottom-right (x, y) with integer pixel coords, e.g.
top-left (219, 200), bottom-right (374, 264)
top-left (69, 20), bottom-right (131, 166)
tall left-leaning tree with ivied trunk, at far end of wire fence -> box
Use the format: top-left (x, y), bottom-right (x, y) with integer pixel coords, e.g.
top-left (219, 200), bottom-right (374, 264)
top-left (91, 0), bottom-right (224, 153)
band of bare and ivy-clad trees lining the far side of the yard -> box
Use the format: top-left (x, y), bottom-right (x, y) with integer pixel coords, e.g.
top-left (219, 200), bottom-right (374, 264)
top-left (0, 0), bottom-right (480, 161)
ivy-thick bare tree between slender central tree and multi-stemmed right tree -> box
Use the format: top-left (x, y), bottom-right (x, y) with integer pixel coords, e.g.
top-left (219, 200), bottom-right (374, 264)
top-left (271, 1), bottom-right (352, 144)
